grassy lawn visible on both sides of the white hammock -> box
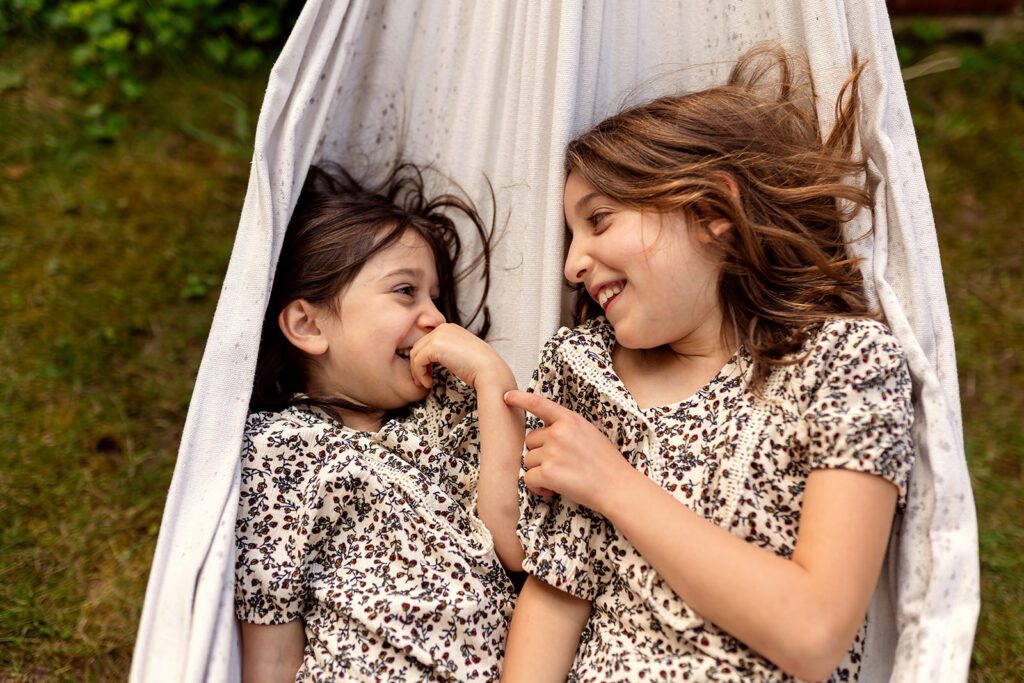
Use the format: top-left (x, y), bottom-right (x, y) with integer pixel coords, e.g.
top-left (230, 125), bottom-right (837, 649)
top-left (0, 28), bottom-right (1024, 681)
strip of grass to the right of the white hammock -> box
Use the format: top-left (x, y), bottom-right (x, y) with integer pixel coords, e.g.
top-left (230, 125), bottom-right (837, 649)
top-left (903, 33), bottom-right (1024, 681)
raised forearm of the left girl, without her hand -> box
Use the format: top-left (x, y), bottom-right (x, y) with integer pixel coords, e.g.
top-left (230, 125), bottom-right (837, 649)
top-left (476, 369), bottom-right (525, 571)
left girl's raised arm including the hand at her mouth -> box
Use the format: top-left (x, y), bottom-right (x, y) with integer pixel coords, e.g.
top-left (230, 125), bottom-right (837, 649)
top-left (410, 324), bottom-right (525, 571)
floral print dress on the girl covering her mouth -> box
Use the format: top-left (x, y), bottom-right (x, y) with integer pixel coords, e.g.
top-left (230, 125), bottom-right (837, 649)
top-left (234, 371), bottom-right (514, 681)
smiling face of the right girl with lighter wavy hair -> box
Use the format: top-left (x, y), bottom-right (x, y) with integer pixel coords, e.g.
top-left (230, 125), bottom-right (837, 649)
top-left (564, 173), bottom-right (722, 353)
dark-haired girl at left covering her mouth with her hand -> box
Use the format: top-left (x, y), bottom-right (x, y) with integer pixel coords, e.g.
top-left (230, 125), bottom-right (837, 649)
top-left (236, 165), bottom-right (523, 681)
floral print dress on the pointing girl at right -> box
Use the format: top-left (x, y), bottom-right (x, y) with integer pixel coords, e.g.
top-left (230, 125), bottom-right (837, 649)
top-left (518, 317), bottom-right (913, 682)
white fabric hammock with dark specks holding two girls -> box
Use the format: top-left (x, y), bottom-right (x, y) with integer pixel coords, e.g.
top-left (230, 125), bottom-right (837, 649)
top-left (131, 0), bottom-right (978, 683)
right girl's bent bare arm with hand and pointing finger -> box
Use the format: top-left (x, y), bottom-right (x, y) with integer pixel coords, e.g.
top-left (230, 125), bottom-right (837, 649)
top-left (508, 392), bottom-right (896, 679)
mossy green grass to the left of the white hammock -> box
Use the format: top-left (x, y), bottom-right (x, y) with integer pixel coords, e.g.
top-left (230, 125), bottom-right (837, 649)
top-left (0, 43), bottom-right (266, 680)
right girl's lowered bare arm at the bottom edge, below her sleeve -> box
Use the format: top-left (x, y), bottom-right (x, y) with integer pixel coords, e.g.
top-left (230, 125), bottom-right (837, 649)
top-left (502, 577), bottom-right (590, 683)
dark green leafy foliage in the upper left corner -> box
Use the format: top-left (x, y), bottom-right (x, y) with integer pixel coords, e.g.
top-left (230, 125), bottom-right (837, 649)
top-left (0, 0), bottom-right (301, 140)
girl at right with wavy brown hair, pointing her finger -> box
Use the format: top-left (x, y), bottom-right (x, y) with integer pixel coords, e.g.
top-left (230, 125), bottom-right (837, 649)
top-left (504, 47), bottom-right (913, 683)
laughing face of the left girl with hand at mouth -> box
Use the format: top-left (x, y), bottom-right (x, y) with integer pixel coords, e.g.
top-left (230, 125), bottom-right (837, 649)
top-left (310, 231), bottom-right (444, 412)
